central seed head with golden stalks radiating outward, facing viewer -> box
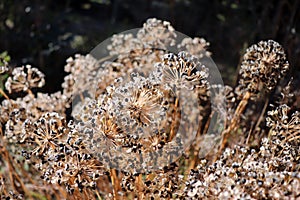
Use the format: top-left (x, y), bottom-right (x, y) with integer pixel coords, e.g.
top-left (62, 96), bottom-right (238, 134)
top-left (111, 75), bottom-right (165, 129)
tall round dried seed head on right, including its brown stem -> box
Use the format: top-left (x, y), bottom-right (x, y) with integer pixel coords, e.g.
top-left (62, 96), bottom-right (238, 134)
top-left (220, 40), bottom-right (289, 151)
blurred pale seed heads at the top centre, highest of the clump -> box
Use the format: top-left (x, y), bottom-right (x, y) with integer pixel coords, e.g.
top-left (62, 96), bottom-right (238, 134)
top-left (104, 18), bottom-right (176, 78)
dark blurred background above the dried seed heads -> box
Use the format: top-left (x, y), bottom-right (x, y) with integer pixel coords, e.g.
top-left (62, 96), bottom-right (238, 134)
top-left (0, 0), bottom-right (300, 92)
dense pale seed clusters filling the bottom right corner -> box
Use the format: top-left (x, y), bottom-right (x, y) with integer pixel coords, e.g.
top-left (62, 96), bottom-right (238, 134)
top-left (184, 138), bottom-right (300, 199)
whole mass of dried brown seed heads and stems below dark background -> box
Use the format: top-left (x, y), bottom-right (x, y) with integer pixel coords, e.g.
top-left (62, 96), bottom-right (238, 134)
top-left (0, 19), bottom-right (300, 199)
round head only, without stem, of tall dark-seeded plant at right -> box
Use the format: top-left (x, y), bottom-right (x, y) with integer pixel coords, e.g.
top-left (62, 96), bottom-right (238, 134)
top-left (238, 40), bottom-right (289, 97)
